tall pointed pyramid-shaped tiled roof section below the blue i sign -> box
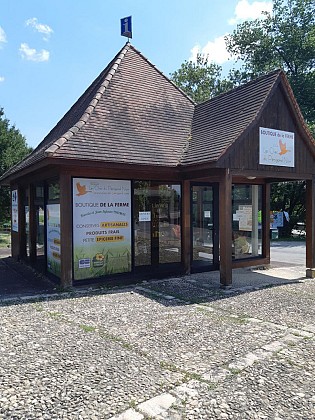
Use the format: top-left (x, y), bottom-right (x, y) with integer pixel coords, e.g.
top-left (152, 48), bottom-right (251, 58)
top-left (4, 43), bottom-right (194, 182)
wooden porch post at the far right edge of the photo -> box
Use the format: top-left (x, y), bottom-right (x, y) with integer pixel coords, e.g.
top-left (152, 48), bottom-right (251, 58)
top-left (306, 177), bottom-right (315, 278)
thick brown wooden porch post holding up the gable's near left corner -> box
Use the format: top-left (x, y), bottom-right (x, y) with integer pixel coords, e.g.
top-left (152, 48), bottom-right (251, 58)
top-left (219, 169), bottom-right (232, 288)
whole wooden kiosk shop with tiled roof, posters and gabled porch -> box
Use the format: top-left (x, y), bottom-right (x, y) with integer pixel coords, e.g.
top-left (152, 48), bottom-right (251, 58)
top-left (0, 43), bottom-right (315, 287)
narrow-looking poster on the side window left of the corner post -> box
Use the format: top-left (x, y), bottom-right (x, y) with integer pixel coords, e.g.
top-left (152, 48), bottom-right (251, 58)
top-left (46, 204), bottom-right (61, 277)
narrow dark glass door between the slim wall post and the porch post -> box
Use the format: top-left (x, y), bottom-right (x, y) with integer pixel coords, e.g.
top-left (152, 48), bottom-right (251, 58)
top-left (191, 184), bottom-right (219, 270)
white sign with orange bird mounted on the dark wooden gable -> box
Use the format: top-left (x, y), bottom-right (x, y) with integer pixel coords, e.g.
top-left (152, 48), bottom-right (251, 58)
top-left (259, 127), bottom-right (294, 168)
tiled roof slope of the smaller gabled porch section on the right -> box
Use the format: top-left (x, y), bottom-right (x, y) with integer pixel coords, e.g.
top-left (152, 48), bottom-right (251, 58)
top-left (182, 70), bottom-right (281, 165)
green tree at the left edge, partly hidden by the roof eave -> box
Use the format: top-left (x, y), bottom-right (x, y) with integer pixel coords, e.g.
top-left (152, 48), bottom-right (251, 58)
top-left (0, 108), bottom-right (32, 223)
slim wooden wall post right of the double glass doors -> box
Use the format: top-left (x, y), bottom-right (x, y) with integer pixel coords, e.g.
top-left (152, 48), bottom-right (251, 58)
top-left (182, 181), bottom-right (191, 274)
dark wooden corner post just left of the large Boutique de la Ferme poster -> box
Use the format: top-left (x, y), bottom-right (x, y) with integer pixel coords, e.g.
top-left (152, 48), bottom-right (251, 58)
top-left (60, 172), bottom-right (72, 289)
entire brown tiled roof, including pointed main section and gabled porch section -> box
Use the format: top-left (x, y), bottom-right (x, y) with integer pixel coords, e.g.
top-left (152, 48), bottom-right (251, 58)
top-left (0, 43), bottom-right (314, 181)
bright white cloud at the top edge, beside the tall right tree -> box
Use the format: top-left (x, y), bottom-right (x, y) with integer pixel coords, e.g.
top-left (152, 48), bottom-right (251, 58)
top-left (229, 0), bottom-right (272, 25)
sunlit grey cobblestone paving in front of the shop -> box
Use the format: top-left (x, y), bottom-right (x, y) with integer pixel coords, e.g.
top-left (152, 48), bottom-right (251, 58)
top-left (0, 275), bottom-right (315, 420)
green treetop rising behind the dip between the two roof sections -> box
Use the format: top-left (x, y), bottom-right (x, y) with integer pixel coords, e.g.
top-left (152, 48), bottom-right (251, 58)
top-left (170, 54), bottom-right (233, 103)
